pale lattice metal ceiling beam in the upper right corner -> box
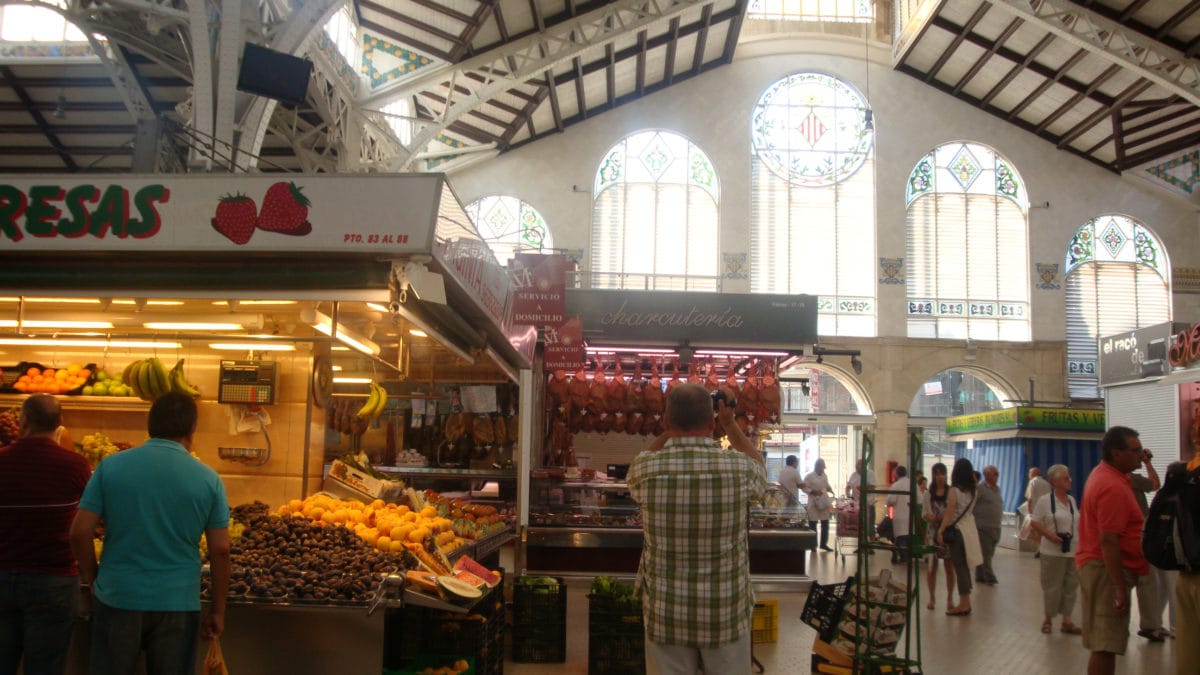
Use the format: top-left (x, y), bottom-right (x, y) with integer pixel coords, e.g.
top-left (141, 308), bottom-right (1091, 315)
top-left (984, 0), bottom-right (1200, 104)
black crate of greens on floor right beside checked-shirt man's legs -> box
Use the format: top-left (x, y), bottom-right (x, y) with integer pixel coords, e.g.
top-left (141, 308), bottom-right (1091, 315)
top-left (588, 595), bottom-right (646, 675)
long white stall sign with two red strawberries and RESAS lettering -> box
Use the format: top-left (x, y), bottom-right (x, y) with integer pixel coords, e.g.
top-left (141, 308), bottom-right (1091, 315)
top-left (0, 174), bottom-right (456, 255)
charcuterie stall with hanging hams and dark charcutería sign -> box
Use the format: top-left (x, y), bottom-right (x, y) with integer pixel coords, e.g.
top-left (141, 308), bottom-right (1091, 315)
top-left (521, 289), bottom-right (816, 583)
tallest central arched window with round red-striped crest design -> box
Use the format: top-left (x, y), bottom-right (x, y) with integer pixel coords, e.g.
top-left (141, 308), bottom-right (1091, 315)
top-left (750, 72), bottom-right (876, 336)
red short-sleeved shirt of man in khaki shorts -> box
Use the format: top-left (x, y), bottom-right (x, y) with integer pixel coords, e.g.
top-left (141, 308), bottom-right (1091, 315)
top-left (1075, 461), bottom-right (1150, 577)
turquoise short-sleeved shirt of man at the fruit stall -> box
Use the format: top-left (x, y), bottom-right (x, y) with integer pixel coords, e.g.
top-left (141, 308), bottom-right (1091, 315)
top-left (79, 438), bottom-right (229, 611)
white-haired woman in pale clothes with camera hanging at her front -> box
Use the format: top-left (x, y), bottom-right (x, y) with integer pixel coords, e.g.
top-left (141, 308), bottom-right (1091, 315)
top-left (1031, 464), bottom-right (1081, 635)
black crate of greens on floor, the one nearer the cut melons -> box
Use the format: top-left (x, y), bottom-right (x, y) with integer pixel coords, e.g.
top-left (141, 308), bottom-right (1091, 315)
top-left (512, 577), bottom-right (566, 663)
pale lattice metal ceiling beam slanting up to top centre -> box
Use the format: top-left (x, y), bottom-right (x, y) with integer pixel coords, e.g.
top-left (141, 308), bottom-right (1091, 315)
top-left (365, 0), bottom-right (713, 169)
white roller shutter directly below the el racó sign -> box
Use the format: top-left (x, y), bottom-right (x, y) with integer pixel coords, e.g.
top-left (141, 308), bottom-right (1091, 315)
top-left (1104, 382), bottom-right (1180, 478)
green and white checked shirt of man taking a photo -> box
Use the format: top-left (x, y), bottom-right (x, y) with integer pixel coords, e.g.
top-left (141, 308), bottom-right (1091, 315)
top-left (628, 437), bottom-right (767, 649)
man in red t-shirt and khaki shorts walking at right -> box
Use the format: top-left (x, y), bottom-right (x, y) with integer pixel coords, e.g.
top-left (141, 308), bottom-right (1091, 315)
top-left (1075, 426), bottom-right (1150, 675)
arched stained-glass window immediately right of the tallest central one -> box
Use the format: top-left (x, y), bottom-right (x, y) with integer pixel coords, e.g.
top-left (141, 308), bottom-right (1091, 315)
top-left (905, 143), bottom-right (1030, 341)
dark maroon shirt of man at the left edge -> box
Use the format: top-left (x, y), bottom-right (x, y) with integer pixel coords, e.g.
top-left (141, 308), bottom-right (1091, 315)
top-left (0, 436), bottom-right (91, 577)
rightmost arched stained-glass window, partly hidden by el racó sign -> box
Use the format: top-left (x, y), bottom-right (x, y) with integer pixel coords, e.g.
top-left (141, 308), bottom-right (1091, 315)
top-left (1063, 215), bottom-right (1171, 399)
